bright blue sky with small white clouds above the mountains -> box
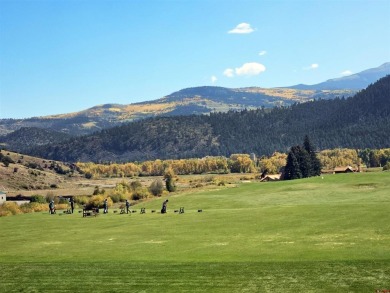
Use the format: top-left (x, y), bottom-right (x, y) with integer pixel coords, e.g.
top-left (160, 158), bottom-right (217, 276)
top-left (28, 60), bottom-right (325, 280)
top-left (0, 0), bottom-right (390, 118)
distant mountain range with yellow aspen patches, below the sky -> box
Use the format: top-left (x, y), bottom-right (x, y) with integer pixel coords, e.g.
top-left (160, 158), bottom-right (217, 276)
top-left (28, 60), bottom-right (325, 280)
top-left (0, 63), bottom-right (390, 137)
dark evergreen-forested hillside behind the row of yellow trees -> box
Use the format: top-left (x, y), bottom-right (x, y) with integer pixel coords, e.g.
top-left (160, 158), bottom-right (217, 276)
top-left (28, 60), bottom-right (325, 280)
top-left (25, 76), bottom-right (390, 162)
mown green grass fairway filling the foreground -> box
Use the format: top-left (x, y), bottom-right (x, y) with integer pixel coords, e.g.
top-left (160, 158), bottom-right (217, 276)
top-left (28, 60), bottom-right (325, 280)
top-left (0, 172), bottom-right (390, 292)
